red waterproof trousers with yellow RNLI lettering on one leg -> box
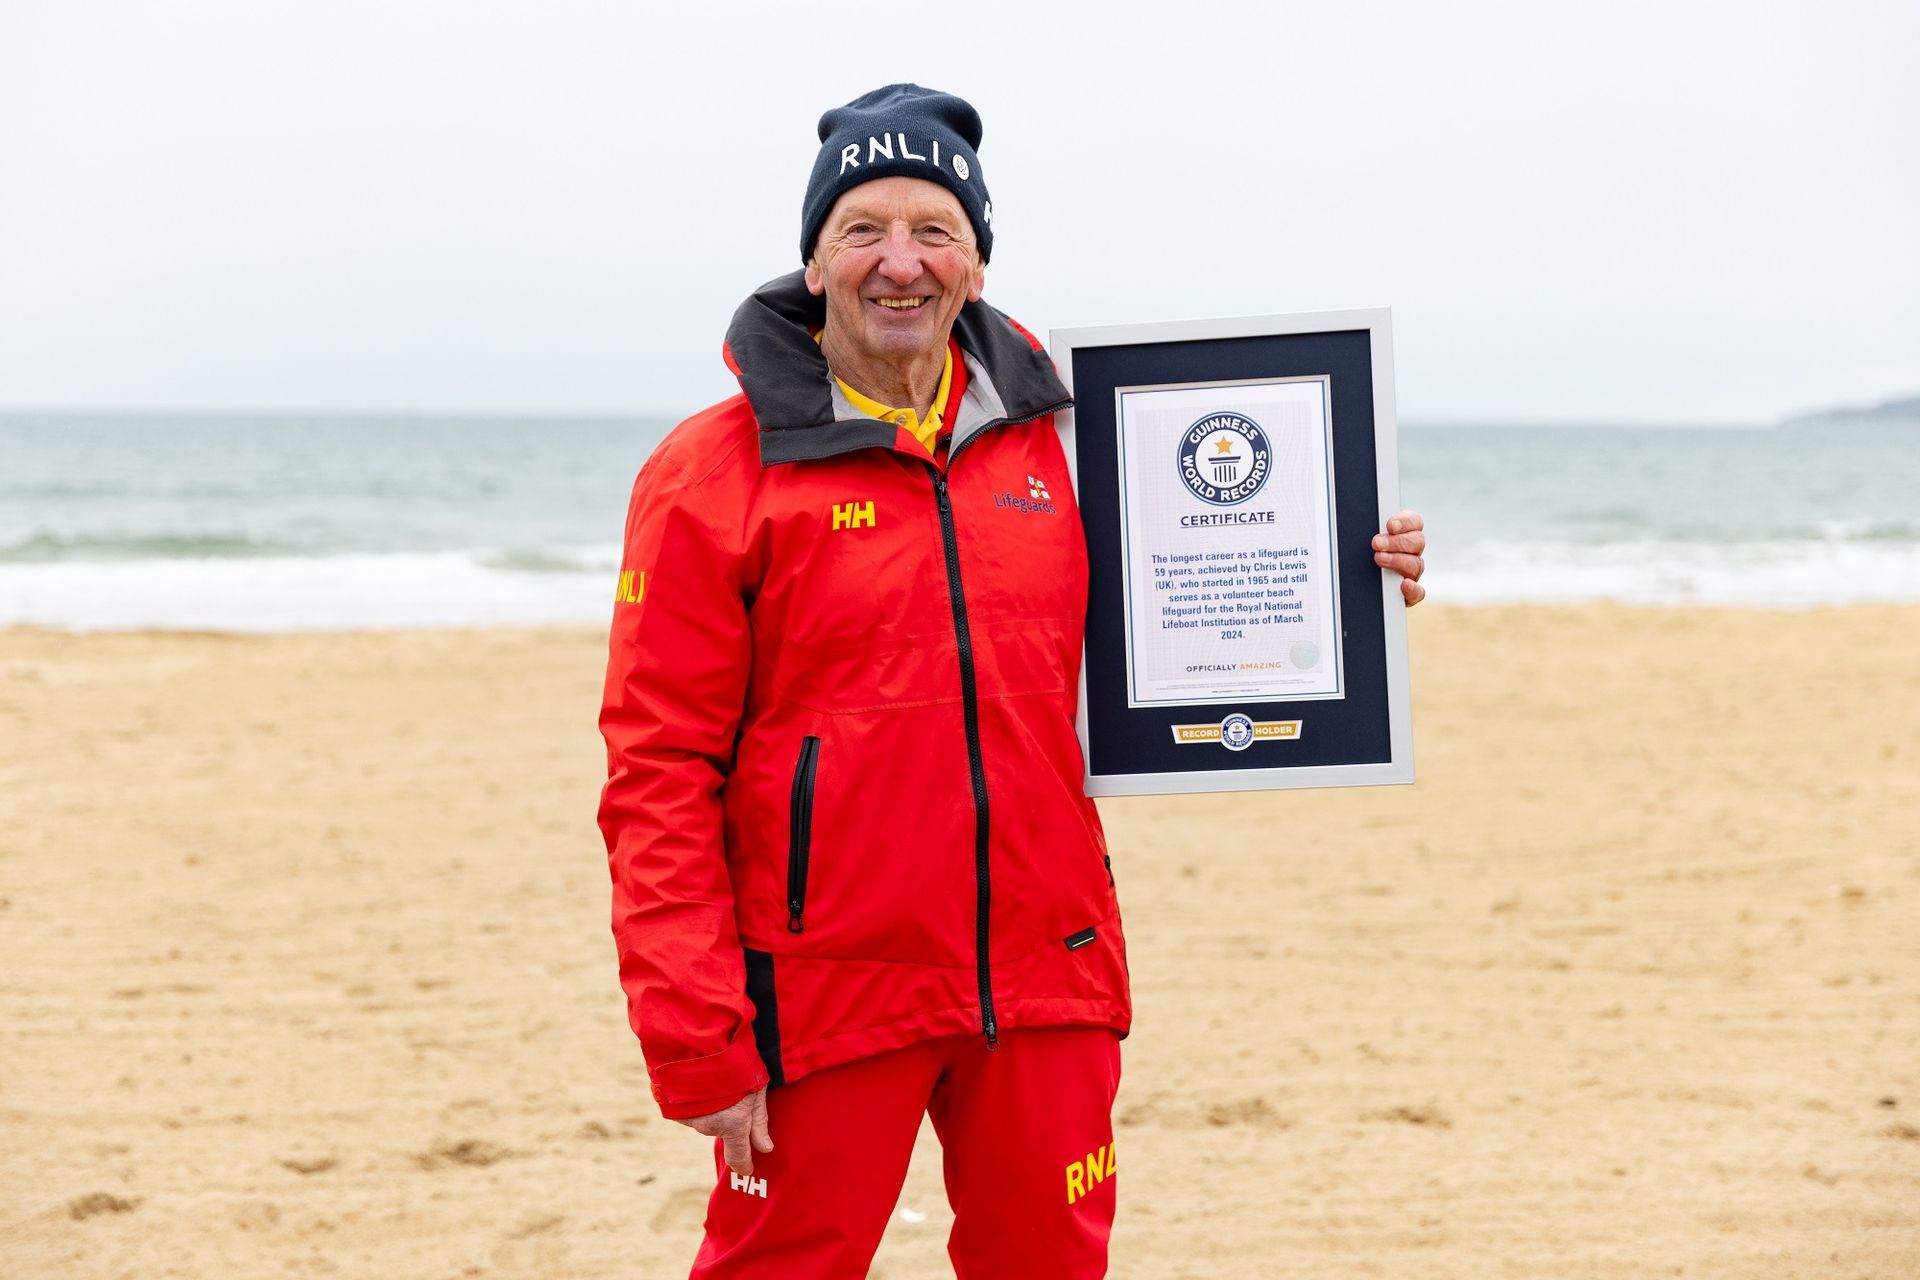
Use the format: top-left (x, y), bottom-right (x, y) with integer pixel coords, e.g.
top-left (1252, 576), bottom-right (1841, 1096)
top-left (691, 1027), bottom-right (1119, 1280)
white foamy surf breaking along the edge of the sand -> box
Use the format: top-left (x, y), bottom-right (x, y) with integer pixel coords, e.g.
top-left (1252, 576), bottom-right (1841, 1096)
top-left (0, 541), bottom-right (1920, 631)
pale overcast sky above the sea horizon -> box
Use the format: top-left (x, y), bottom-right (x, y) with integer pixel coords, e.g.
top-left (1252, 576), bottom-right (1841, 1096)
top-left (0, 0), bottom-right (1920, 422)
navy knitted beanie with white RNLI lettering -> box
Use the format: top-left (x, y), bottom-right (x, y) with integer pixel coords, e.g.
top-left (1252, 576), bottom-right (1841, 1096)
top-left (801, 84), bottom-right (993, 263)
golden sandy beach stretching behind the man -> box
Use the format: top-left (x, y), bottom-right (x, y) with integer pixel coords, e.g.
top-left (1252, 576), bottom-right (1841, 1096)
top-left (0, 604), bottom-right (1920, 1280)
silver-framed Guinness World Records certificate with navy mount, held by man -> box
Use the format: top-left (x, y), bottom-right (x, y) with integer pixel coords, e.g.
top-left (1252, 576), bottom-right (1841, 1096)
top-left (1050, 311), bottom-right (1413, 796)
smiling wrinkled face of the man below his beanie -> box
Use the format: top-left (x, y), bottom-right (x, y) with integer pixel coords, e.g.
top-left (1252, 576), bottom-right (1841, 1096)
top-left (806, 177), bottom-right (987, 363)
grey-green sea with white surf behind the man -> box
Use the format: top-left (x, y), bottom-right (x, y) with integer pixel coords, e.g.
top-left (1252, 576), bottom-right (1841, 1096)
top-left (0, 413), bottom-right (1920, 631)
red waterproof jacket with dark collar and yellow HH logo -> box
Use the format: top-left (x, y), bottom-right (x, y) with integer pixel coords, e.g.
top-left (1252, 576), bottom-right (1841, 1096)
top-left (599, 273), bottom-right (1131, 1119)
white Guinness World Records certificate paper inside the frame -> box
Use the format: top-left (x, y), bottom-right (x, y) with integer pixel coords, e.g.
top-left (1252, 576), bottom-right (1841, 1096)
top-left (1114, 376), bottom-right (1346, 706)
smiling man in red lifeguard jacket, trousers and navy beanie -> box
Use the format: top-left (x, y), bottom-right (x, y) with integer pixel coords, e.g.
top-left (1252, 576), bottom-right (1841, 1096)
top-left (601, 84), bottom-right (1425, 1280)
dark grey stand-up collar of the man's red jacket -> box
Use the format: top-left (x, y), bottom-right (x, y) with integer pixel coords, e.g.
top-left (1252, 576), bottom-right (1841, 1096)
top-left (726, 271), bottom-right (1073, 466)
